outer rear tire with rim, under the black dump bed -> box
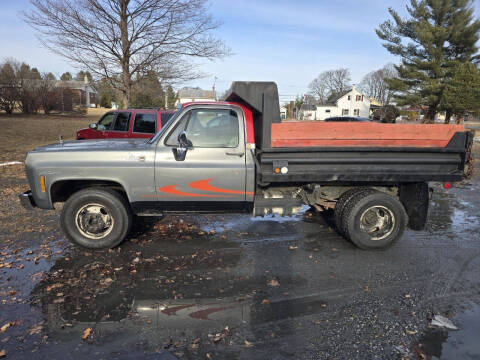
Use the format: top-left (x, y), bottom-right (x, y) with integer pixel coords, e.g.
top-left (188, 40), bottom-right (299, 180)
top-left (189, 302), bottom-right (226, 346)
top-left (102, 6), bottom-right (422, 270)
top-left (342, 189), bottom-right (408, 250)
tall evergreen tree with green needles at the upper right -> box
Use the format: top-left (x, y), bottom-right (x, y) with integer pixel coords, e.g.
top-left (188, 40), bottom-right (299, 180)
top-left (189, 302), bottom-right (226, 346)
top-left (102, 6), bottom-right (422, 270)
top-left (376, 0), bottom-right (480, 122)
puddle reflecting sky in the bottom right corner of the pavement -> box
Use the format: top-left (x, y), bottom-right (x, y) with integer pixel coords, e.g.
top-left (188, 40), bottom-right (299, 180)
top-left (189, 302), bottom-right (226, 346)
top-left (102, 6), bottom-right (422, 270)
top-left (419, 305), bottom-right (480, 359)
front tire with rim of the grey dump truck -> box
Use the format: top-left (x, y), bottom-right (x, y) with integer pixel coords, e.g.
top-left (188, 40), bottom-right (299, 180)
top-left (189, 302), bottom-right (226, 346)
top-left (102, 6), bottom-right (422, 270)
top-left (60, 188), bottom-right (132, 249)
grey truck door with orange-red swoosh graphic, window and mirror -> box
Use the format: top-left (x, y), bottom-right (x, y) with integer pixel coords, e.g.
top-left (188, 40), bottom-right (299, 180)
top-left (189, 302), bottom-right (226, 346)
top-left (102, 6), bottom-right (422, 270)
top-left (155, 106), bottom-right (247, 211)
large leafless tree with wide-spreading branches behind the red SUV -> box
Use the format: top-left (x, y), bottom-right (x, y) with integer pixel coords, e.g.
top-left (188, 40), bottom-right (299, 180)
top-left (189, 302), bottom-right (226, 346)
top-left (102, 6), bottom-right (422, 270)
top-left (23, 0), bottom-right (229, 107)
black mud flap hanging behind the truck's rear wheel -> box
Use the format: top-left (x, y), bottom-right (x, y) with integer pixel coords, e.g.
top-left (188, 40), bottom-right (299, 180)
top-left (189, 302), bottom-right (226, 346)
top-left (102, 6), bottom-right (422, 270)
top-left (399, 182), bottom-right (430, 231)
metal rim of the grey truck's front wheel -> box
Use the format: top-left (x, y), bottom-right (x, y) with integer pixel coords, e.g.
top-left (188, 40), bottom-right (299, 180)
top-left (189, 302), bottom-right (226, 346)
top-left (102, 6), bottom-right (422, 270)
top-left (75, 204), bottom-right (114, 240)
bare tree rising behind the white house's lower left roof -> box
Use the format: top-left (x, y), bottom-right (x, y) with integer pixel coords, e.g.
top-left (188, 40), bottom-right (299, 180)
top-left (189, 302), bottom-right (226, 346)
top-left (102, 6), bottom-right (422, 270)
top-left (309, 68), bottom-right (352, 103)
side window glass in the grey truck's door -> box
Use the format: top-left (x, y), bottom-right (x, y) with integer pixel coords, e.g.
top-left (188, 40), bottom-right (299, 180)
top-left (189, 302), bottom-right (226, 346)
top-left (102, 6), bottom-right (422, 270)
top-left (186, 109), bottom-right (238, 148)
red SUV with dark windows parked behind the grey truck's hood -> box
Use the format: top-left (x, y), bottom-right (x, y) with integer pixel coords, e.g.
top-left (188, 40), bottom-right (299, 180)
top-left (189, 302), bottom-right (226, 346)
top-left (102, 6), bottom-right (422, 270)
top-left (77, 109), bottom-right (175, 140)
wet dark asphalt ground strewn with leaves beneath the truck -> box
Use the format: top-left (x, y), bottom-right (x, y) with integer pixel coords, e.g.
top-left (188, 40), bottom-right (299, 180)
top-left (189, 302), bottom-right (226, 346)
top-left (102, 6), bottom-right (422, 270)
top-left (0, 168), bottom-right (480, 359)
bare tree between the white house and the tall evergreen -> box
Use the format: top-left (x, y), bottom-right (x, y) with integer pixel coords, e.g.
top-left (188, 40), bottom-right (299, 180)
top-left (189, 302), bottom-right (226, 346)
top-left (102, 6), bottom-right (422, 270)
top-left (358, 64), bottom-right (397, 105)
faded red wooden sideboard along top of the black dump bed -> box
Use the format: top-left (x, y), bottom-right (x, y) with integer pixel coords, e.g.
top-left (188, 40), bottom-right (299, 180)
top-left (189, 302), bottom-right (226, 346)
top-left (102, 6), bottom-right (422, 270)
top-left (271, 122), bottom-right (465, 148)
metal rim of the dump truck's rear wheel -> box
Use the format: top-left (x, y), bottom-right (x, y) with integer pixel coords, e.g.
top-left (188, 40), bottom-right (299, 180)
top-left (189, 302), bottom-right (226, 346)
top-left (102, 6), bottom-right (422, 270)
top-left (360, 205), bottom-right (395, 241)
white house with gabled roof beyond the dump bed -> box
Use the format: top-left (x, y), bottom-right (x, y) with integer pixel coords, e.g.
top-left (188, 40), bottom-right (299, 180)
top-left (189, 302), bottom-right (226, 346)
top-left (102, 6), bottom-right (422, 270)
top-left (300, 86), bottom-right (370, 120)
